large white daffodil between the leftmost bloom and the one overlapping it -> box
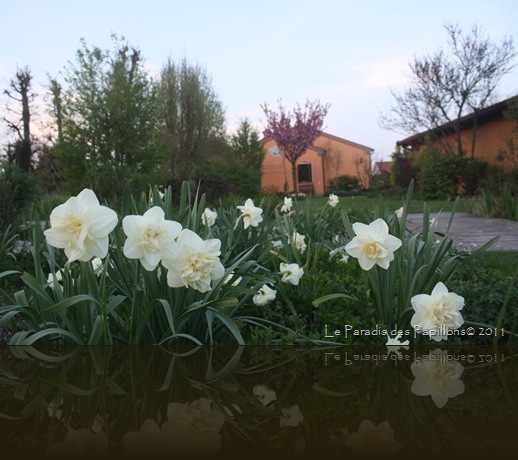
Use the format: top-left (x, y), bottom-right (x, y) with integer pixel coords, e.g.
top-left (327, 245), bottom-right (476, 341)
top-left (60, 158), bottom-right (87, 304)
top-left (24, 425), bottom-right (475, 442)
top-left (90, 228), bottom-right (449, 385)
top-left (122, 206), bottom-right (182, 271)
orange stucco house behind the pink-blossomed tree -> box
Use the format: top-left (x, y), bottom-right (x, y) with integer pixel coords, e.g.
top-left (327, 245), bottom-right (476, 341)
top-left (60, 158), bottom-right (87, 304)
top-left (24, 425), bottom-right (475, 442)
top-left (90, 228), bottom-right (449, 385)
top-left (261, 132), bottom-right (373, 195)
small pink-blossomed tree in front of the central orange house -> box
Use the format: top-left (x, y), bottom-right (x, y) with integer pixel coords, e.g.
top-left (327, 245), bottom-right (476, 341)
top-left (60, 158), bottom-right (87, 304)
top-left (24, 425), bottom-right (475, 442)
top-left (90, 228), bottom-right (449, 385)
top-left (261, 101), bottom-right (329, 193)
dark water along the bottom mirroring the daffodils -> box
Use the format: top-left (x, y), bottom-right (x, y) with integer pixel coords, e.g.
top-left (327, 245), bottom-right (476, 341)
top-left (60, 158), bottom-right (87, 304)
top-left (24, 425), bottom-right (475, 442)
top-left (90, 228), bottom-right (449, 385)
top-left (0, 346), bottom-right (518, 459)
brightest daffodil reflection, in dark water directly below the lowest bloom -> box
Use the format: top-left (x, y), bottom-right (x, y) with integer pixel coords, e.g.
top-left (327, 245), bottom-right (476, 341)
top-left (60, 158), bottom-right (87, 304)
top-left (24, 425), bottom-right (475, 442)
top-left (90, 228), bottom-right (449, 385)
top-left (411, 350), bottom-right (464, 408)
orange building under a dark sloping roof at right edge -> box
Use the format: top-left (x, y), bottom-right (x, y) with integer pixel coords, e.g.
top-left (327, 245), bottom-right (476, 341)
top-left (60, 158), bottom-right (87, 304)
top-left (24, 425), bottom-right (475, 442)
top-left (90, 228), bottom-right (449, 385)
top-left (396, 96), bottom-right (518, 170)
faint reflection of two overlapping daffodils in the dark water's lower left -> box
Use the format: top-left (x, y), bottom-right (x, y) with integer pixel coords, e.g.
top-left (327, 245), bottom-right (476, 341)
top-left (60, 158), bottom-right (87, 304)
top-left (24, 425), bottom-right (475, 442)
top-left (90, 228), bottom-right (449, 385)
top-left (123, 398), bottom-right (225, 457)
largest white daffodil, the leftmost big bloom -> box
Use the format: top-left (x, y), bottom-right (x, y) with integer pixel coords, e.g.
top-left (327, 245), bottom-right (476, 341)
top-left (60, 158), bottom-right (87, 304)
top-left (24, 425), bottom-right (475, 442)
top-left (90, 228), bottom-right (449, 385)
top-left (44, 189), bottom-right (117, 262)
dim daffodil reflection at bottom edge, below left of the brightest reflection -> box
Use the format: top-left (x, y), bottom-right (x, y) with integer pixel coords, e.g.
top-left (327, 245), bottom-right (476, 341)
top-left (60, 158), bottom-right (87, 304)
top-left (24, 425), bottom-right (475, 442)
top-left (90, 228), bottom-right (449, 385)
top-left (345, 420), bottom-right (401, 456)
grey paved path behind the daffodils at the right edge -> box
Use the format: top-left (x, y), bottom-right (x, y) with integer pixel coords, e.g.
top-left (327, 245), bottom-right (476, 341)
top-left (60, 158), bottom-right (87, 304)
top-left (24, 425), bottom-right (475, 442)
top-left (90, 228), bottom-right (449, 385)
top-left (407, 212), bottom-right (518, 251)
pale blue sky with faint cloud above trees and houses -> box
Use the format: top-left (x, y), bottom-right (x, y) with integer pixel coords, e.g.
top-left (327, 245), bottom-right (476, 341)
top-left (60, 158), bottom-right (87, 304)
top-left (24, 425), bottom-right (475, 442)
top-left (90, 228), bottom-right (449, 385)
top-left (0, 0), bottom-right (518, 160)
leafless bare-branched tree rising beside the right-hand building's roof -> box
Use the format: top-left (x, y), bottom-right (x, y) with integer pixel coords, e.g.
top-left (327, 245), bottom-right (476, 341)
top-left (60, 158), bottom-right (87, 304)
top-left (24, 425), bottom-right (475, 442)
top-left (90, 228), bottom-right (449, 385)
top-left (380, 24), bottom-right (517, 160)
